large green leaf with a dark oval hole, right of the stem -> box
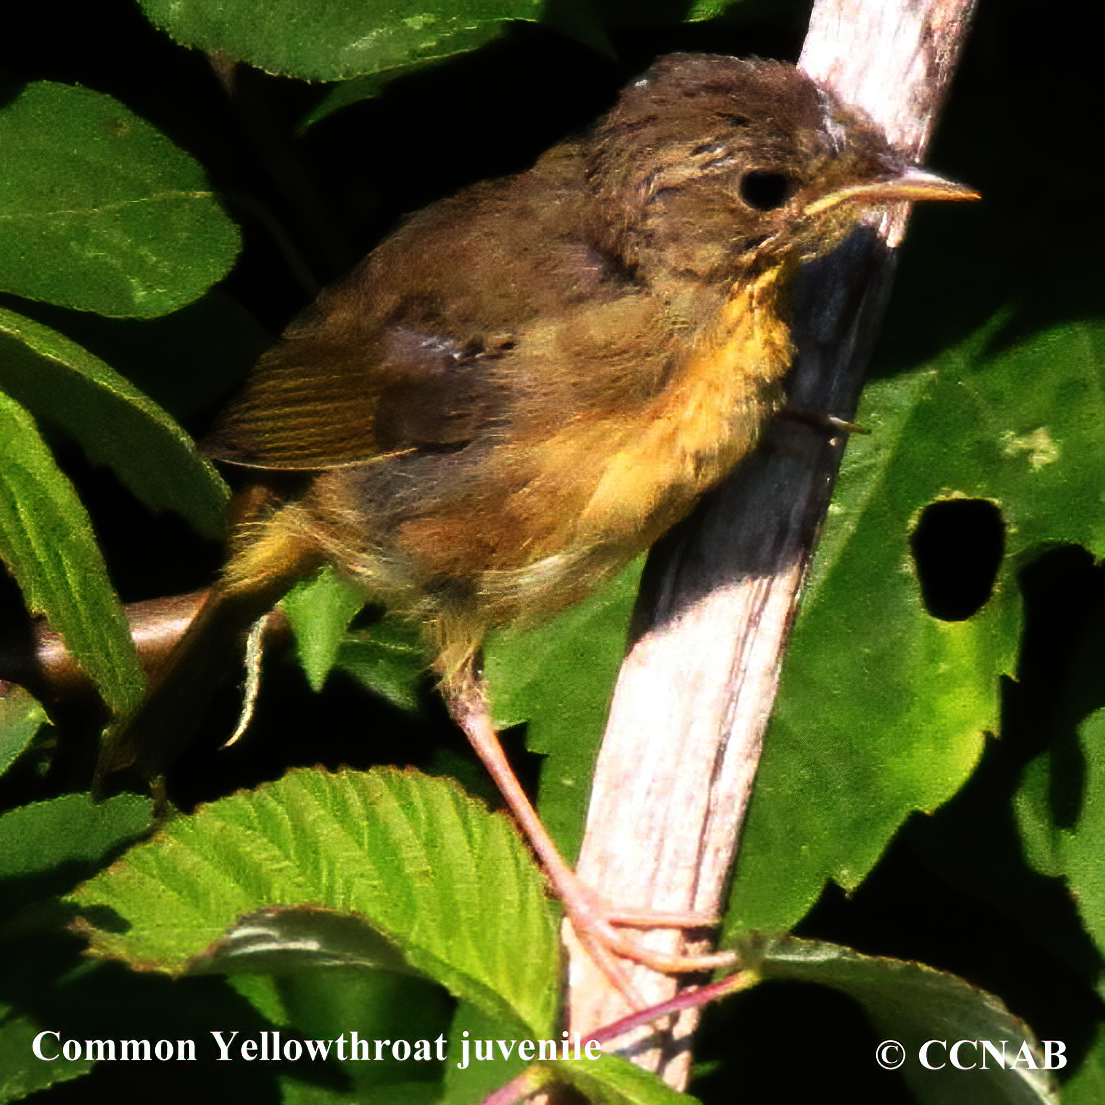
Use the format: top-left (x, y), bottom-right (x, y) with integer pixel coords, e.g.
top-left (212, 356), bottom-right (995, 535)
top-left (728, 315), bottom-right (1105, 933)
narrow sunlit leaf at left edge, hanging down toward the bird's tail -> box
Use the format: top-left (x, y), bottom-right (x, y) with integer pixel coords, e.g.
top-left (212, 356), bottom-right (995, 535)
top-left (0, 394), bottom-right (145, 714)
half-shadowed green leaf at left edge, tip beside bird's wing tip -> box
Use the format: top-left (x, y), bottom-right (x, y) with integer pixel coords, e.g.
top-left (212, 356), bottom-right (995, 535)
top-left (0, 309), bottom-right (229, 538)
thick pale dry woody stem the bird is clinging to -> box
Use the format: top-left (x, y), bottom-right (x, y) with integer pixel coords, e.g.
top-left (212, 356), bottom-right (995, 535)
top-left (566, 0), bottom-right (974, 1088)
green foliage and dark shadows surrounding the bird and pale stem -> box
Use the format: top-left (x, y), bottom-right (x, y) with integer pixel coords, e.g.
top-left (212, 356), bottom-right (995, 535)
top-left (0, 0), bottom-right (1105, 1105)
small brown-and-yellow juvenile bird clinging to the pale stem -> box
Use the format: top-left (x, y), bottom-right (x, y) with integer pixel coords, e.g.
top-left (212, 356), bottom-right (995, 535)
top-left (101, 54), bottom-right (976, 976)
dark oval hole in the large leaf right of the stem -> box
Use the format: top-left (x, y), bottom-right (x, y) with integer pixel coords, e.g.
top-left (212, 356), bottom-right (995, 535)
top-left (911, 498), bottom-right (1006, 621)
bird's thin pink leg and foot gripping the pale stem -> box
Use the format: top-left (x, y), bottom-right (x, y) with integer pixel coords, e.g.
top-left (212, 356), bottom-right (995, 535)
top-left (444, 660), bottom-right (736, 1007)
